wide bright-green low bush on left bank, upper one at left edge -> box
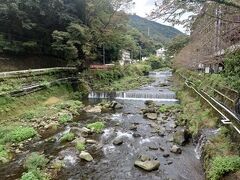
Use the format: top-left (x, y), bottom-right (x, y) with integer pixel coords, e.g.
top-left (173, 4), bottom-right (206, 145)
top-left (2, 126), bottom-right (37, 143)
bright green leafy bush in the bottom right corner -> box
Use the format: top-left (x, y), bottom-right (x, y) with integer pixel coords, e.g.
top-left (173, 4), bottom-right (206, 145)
top-left (207, 156), bottom-right (240, 180)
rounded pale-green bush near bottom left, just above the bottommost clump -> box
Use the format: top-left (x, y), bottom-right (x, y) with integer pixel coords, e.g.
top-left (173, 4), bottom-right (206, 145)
top-left (24, 152), bottom-right (48, 170)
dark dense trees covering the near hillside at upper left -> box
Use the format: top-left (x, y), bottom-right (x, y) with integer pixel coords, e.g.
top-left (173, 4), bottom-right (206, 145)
top-left (0, 0), bottom-right (164, 69)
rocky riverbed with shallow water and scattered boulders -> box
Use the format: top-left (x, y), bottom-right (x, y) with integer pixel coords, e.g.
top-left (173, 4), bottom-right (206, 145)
top-left (0, 73), bottom-right (204, 180)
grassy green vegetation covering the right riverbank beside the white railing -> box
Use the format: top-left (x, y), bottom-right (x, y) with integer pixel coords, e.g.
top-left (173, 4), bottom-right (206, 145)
top-left (174, 73), bottom-right (240, 180)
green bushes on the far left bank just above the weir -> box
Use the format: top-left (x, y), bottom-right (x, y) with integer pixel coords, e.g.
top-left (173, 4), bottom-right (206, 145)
top-left (89, 63), bottom-right (152, 92)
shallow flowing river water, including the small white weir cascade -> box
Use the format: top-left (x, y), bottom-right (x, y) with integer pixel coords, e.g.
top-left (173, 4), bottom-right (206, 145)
top-left (0, 71), bottom-right (204, 180)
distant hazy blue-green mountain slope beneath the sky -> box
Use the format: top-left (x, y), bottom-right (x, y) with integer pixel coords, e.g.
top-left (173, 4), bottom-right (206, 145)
top-left (129, 15), bottom-right (183, 44)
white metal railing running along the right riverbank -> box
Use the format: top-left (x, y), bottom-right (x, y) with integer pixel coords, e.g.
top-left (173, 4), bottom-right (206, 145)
top-left (179, 74), bottom-right (240, 134)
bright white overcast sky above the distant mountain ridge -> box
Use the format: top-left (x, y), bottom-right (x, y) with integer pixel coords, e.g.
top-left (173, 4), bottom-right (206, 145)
top-left (132, 0), bottom-right (185, 32)
